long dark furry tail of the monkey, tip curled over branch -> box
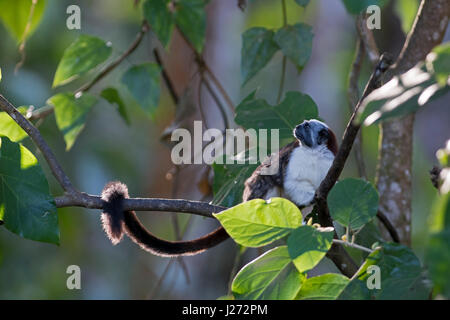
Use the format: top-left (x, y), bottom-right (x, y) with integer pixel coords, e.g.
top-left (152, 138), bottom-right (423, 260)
top-left (101, 182), bottom-right (229, 257)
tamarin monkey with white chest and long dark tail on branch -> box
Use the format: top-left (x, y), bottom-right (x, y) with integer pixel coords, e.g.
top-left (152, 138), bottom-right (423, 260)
top-left (101, 120), bottom-right (337, 257)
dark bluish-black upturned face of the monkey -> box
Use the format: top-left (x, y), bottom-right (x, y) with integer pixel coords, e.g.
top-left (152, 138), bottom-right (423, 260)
top-left (294, 119), bottom-right (330, 149)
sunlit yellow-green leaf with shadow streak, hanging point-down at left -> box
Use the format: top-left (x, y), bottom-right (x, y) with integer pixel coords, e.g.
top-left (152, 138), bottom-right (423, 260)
top-left (47, 92), bottom-right (97, 150)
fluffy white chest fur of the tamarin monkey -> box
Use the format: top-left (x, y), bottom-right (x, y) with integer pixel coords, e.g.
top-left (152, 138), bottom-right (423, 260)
top-left (266, 146), bottom-right (334, 206)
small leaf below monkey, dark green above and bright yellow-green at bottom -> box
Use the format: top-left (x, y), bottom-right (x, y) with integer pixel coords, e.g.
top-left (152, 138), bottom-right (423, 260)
top-left (287, 225), bottom-right (334, 272)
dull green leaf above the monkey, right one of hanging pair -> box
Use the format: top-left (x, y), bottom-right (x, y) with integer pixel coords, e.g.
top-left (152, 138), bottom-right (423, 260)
top-left (274, 23), bottom-right (314, 70)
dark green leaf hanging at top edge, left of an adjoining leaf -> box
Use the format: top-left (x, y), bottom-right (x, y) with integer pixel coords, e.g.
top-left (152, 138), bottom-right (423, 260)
top-left (142, 0), bottom-right (174, 47)
